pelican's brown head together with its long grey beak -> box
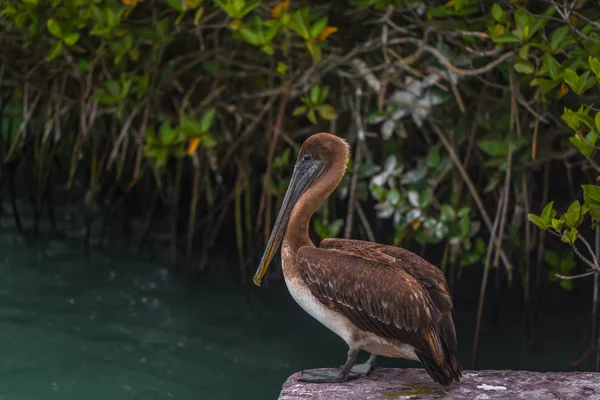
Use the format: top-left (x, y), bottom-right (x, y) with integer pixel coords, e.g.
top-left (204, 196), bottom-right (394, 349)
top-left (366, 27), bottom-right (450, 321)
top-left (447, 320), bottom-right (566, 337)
top-left (253, 133), bottom-right (350, 286)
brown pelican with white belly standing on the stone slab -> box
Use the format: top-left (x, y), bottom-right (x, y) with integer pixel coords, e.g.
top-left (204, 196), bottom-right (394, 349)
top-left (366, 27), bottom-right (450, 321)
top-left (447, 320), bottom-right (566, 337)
top-left (254, 133), bottom-right (462, 386)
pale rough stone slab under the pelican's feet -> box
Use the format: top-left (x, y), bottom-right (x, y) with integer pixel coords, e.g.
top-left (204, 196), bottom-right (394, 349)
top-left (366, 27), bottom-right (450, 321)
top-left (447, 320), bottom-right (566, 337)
top-left (279, 368), bottom-right (600, 400)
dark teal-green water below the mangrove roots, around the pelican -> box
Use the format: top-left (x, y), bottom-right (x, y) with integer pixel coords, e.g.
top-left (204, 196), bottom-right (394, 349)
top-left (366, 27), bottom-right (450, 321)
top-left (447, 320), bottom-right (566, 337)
top-left (0, 214), bottom-right (589, 400)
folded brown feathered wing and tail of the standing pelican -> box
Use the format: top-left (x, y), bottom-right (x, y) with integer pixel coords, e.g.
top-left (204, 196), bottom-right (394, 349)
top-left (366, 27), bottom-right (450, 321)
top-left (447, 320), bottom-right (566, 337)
top-left (296, 239), bottom-right (461, 384)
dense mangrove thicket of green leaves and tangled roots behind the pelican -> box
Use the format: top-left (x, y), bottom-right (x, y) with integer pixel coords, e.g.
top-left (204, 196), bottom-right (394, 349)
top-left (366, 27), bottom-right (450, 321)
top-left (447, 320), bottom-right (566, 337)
top-left (0, 0), bottom-right (600, 368)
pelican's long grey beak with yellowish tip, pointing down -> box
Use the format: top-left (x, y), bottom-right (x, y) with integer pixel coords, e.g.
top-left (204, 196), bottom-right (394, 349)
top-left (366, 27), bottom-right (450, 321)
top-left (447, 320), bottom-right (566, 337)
top-left (253, 164), bottom-right (321, 286)
